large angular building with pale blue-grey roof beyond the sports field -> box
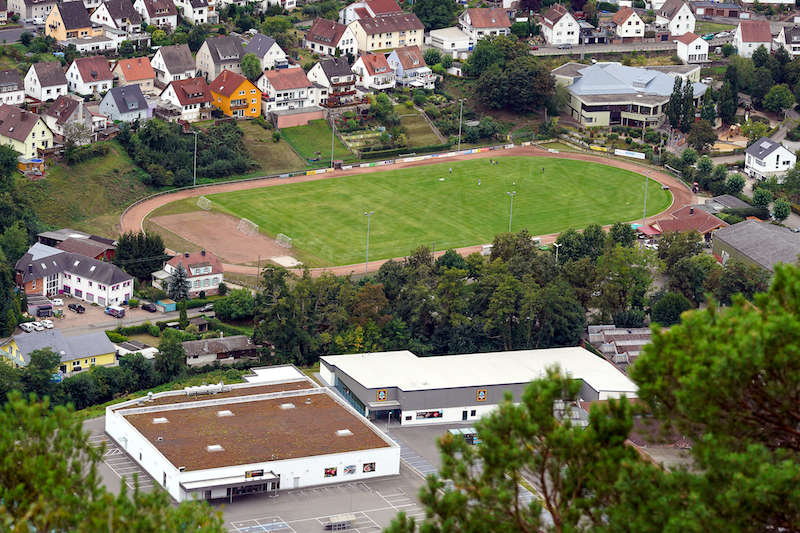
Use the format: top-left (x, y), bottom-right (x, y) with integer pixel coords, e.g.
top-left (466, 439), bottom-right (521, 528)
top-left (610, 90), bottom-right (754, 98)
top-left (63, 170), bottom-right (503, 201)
top-left (552, 63), bottom-right (708, 127)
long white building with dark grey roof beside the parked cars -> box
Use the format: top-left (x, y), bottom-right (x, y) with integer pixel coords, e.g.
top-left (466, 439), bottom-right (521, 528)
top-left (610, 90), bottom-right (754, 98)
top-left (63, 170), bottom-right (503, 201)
top-left (15, 243), bottom-right (133, 306)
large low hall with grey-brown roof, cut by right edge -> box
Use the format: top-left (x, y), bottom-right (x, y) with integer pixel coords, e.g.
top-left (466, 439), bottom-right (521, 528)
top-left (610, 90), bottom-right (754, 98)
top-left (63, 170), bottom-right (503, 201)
top-left (711, 220), bottom-right (800, 272)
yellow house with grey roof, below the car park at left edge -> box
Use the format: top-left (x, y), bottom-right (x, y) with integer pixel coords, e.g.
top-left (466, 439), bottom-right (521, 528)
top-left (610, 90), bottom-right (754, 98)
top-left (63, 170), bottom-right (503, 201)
top-left (0, 329), bottom-right (117, 376)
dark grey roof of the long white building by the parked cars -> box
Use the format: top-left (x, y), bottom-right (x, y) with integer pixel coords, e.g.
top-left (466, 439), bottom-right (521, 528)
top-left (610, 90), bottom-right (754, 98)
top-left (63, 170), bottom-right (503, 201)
top-left (15, 243), bottom-right (132, 285)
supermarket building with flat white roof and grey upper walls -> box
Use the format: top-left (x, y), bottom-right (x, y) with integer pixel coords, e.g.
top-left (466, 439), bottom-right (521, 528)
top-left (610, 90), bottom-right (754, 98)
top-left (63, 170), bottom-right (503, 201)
top-left (320, 347), bottom-right (637, 425)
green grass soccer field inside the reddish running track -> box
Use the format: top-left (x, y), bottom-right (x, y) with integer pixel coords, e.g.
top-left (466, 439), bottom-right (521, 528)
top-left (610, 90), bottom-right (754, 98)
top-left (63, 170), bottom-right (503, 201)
top-left (208, 157), bottom-right (672, 266)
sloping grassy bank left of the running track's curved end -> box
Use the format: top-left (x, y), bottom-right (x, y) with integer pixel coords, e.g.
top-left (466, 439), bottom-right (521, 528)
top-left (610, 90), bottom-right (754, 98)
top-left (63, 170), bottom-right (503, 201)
top-left (18, 142), bottom-right (152, 237)
